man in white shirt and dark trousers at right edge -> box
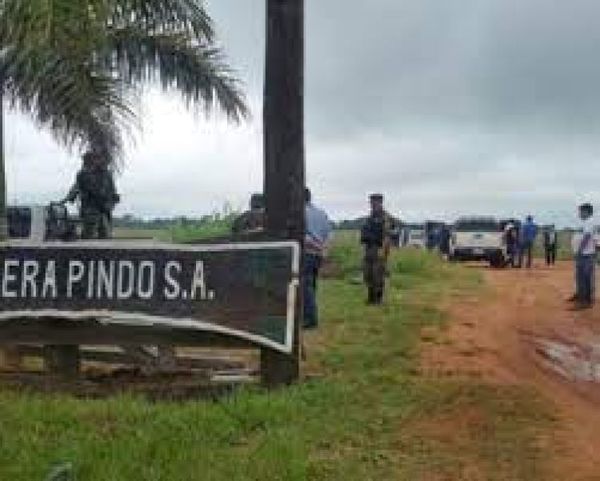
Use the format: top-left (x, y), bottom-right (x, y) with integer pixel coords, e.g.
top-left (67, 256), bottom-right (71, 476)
top-left (569, 203), bottom-right (596, 310)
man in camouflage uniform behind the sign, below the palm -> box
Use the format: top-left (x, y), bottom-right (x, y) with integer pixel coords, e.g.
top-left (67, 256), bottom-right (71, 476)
top-left (64, 152), bottom-right (120, 239)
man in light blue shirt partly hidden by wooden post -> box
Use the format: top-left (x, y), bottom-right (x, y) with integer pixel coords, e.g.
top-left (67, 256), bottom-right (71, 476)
top-left (304, 189), bottom-right (331, 329)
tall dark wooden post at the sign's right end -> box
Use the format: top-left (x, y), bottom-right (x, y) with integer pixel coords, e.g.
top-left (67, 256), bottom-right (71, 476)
top-left (261, 0), bottom-right (305, 386)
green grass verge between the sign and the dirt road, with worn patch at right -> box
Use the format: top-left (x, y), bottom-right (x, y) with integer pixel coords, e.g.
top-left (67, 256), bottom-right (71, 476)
top-left (0, 233), bottom-right (553, 481)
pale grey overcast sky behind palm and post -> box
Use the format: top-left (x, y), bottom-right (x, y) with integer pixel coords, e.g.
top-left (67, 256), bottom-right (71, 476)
top-left (6, 0), bottom-right (600, 223)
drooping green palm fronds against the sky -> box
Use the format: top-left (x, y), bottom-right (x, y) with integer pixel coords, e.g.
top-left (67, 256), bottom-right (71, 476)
top-left (0, 0), bottom-right (248, 238)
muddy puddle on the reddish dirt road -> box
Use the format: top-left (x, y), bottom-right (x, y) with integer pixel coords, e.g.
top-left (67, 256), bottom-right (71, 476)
top-left (529, 337), bottom-right (600, 384)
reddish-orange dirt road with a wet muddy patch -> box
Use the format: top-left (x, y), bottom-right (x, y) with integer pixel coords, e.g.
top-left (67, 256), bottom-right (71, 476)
top-left (423, 262), bottom-right (600, 481)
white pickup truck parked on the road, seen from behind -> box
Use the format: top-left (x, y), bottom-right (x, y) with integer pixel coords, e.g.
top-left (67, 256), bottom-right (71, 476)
top-left (450, 217), bottom-right (508, 267)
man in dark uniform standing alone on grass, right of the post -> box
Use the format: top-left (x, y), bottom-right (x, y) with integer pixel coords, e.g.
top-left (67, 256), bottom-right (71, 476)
top-left (360, 194), bottom-right (392, 304)
